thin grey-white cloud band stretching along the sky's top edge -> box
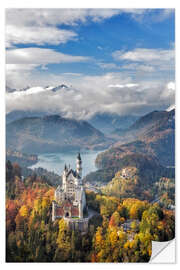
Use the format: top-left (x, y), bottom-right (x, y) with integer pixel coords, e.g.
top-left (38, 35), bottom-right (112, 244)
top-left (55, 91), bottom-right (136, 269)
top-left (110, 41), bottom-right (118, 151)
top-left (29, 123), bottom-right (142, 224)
top-left (6, 8), bottom-right (174, 26)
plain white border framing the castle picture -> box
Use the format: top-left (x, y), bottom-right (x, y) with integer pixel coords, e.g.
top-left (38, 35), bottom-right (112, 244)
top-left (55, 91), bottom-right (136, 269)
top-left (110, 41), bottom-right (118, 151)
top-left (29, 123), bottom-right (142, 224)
top-left (0, 0), bottom-right (180, 270)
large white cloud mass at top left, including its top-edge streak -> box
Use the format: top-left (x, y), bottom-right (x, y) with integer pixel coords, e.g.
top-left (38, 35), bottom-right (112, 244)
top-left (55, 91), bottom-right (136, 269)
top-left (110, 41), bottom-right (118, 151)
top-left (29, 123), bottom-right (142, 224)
top-left (6, 8), bottom-right (174, 48)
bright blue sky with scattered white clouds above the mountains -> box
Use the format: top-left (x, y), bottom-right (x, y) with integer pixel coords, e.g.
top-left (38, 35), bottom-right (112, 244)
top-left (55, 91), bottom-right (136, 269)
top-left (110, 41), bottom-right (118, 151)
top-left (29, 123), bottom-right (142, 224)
top-left (6, 9), bottom-right (175, 117)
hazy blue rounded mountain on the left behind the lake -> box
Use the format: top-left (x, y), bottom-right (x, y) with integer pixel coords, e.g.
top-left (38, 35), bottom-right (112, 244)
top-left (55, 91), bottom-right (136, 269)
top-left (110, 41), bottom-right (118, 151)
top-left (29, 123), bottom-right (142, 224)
top-left (6, 115), bottom-right (113, 154)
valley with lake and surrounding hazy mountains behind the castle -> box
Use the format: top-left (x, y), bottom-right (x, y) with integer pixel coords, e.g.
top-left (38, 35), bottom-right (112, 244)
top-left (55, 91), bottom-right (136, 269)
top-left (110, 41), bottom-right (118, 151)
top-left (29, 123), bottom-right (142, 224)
top-left (7, 109), bottom-right (175, 195)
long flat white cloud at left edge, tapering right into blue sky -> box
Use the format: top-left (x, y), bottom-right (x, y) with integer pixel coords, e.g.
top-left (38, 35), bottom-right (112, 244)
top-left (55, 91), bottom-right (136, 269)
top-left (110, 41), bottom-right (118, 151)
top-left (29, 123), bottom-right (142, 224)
top-left (6, 48), bottom-right (90, 65)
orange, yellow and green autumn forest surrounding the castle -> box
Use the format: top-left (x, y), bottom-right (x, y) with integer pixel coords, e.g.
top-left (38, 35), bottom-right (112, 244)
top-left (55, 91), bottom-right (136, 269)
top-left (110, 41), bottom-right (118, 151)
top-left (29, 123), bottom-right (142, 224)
top-left (6, 161), bottom-right (175, 262)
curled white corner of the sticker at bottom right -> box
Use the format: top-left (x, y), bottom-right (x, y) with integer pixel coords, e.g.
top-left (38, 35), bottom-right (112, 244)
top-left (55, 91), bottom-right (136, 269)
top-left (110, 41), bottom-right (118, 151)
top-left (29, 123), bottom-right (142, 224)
top-left (149, 239), bottom-right (176, 263)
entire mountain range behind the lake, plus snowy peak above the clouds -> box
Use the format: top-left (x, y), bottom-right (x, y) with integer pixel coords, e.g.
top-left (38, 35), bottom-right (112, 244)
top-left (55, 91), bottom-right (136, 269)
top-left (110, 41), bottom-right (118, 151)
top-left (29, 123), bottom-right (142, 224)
top-left (6, 84), bottom-right (175, 178)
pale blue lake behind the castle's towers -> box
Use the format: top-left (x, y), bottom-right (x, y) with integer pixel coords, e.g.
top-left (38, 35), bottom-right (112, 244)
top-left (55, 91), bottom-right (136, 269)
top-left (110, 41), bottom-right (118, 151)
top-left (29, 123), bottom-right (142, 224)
top-left (29, 151), bottom-right (102, 177)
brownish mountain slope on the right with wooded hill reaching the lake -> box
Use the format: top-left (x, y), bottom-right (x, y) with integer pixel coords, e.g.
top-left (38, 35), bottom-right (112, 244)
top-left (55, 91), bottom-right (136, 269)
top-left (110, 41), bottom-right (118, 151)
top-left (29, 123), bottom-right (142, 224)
top-left (85, 109), bottom-right (175, 183)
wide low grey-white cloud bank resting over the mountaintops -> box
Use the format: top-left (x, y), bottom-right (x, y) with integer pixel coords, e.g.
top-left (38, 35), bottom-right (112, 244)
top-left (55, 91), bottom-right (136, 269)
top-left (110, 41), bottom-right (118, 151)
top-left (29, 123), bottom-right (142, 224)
top-left (6, 69), bottom-right (175, 119)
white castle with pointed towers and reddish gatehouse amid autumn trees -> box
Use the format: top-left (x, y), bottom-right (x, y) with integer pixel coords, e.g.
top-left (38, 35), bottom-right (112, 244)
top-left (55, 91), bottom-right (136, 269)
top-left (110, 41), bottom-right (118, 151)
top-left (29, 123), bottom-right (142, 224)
top-left (52, 153), bottom-right (88, 231)
